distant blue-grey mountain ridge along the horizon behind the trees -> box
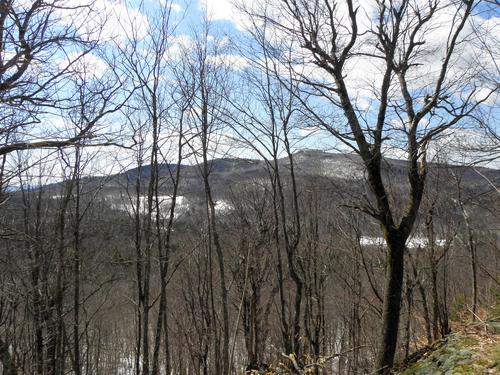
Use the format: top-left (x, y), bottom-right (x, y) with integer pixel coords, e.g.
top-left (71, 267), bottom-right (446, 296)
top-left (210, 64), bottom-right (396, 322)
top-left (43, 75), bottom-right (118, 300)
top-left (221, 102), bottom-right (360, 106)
top-left (33, 150), bottom-right (500, 204)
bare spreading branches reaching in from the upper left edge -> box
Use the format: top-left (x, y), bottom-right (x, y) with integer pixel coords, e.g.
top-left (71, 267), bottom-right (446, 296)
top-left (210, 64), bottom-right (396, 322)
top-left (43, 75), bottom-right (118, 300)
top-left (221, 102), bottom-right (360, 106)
top-left (0, 0), bottom-right (118, 156)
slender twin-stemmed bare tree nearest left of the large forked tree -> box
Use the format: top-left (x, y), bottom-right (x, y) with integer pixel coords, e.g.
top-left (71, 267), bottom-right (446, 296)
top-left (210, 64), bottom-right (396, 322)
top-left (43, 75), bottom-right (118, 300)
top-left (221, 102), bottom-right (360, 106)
top-left (227, 18), bottom-right (311, 366)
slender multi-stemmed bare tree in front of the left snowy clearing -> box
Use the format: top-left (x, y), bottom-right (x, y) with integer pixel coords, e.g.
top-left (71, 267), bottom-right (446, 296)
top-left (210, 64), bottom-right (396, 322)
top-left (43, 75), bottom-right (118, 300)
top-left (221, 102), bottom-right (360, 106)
top-left (118, 2), bottom-right (186, 374)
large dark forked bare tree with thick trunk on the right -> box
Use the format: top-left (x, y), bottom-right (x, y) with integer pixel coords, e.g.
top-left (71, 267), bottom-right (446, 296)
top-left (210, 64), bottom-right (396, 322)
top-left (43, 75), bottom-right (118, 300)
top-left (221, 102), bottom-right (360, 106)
top-left (248, 0), bottom-right (497, 373)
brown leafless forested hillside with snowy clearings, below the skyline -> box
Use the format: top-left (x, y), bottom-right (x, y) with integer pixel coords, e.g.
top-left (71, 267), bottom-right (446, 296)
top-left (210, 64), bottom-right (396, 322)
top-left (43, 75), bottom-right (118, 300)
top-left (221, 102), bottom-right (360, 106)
top-left (2, 152), bottom-right (500, 374)
